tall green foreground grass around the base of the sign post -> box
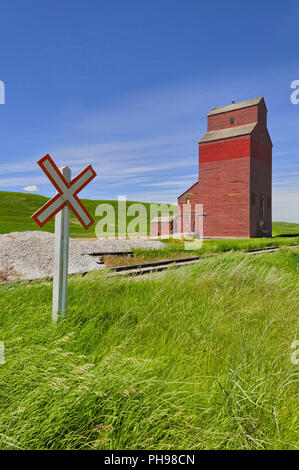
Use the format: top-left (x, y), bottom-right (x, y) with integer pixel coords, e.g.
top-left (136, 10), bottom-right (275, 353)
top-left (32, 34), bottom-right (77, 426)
top-left (0, 248), bottom-right (299, 449)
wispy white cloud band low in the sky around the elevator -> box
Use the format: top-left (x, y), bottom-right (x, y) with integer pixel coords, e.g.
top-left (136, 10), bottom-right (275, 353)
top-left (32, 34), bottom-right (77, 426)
top-left (0, 70), bottom-right (299, 221)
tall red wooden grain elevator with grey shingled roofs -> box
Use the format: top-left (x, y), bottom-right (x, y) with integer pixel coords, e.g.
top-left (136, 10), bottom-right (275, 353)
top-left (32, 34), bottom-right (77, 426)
top-left (178, 98), bottom-right (272, 238)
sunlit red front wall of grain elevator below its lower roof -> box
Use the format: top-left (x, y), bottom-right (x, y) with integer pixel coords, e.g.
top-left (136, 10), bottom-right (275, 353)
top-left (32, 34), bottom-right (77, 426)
top-left (199, 136), bottom-right (250, 237)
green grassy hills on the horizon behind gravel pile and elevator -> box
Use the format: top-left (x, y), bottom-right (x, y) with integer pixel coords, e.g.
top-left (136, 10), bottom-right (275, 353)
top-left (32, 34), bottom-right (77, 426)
top-left (0, 191), bottom-right (299, 237)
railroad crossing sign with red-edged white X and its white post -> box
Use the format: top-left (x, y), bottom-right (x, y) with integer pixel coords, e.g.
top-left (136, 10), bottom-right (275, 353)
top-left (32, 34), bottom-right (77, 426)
top-left (32, 155), bottom-right (96, 322)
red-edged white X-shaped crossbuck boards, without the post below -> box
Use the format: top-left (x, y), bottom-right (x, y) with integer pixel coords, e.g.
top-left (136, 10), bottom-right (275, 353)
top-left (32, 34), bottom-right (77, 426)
top-left (32, 155), bottom-right (96, 229)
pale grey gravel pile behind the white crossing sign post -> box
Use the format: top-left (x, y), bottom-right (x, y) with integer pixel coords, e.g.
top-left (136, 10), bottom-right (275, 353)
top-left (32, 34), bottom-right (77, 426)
top-left (0, 232), bottom-right (164, 280)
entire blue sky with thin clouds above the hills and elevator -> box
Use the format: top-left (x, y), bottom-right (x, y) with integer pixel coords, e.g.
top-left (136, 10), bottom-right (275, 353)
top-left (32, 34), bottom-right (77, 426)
top-left (0, 0), bottom-right (299, 222)
